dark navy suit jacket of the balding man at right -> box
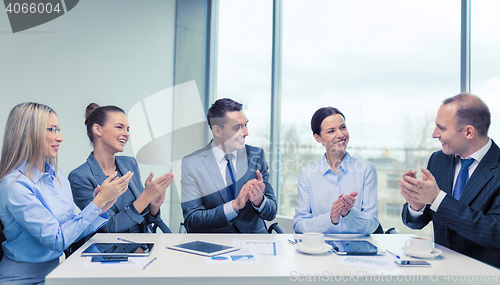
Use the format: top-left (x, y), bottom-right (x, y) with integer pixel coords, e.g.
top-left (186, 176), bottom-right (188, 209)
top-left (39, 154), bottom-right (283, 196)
top-left (402, 142), bottom-right (500, 268)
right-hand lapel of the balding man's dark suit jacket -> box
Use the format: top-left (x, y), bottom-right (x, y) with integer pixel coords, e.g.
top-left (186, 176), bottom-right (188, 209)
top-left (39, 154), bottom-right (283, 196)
top-left (460, 141), bottom-right (500, 205)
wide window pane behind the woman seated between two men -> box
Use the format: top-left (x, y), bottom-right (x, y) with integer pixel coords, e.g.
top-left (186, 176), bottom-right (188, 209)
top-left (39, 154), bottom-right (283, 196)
top-left (279, 0), bottom-right (460, 235)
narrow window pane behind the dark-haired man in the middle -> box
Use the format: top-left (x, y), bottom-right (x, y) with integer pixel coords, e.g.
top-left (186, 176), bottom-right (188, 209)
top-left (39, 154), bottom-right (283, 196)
top-left (216, 0), bottom-right (273, 150)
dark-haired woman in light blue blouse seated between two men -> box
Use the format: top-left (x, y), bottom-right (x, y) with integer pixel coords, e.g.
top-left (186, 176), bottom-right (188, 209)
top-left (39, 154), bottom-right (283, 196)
top-left (293, 107), bottom-right (379, 235)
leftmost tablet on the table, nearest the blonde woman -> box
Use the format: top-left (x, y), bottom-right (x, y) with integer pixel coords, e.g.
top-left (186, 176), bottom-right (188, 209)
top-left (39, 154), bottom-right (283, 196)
top-left (82, 243), bottom-right (154, 256)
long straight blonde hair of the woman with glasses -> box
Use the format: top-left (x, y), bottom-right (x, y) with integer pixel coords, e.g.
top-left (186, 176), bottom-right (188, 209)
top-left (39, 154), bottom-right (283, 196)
top-left (0, 102), bottom-right (57, 179)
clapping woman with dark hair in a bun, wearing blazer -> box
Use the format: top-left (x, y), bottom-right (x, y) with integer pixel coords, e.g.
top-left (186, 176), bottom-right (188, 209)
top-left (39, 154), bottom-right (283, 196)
top-left (69, 103), bottom-right (174, 233)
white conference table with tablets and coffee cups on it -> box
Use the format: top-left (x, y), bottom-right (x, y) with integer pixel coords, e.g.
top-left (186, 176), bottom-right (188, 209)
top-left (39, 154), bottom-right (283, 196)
top-left (46, 234), bottom-right (500, 285)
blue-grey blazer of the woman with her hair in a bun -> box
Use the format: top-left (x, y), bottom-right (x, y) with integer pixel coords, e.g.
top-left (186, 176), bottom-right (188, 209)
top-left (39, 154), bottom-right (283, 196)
top-left (68, 153), bottom-right (161, 233)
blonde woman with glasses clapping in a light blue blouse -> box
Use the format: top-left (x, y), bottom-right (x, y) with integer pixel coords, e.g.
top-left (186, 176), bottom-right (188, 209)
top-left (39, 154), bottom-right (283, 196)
top-left (0, 103), bottom-right (131, 285)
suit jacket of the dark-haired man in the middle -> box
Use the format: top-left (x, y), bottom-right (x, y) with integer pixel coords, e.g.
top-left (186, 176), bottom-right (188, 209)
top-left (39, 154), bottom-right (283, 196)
top-left (181, 143), bottom-right (277, 233)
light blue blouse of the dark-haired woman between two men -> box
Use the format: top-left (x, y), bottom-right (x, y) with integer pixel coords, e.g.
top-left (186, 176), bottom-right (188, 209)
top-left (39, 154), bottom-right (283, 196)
top-left (293, 153), bottom-right (379, 235)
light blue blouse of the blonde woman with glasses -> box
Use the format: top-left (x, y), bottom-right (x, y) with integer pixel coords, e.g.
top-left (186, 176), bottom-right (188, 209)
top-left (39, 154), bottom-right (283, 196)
top-left (0, 163), bottom-right (109, 263)
